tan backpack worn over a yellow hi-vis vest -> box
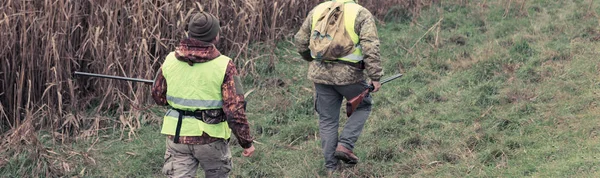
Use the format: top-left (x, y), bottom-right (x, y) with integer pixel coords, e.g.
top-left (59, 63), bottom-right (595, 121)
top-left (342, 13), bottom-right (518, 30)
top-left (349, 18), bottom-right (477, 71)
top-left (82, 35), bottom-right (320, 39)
top-left (308, 1), bottom-right (355, 60)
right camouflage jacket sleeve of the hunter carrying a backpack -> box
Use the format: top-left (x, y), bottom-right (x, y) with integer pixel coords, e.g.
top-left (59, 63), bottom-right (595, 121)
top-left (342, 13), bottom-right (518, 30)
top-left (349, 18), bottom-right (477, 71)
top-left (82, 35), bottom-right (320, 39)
top-left (355, 8), bottom-right (383, 81)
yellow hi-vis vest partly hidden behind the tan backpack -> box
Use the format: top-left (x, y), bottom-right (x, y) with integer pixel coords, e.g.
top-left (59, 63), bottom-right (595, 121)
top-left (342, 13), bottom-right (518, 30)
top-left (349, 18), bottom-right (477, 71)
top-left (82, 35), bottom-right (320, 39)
top-left (311, 0), bottom-right (364, 63)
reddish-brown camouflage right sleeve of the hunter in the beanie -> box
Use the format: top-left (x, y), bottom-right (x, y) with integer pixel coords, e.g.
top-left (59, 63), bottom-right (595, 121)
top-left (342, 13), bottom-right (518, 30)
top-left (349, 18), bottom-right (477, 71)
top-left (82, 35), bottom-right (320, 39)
top-left (221, 61), bottom-right (253, 148)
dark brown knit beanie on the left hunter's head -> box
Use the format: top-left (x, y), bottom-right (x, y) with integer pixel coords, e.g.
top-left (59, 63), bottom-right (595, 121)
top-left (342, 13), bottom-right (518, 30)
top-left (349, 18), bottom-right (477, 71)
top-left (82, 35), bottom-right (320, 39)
top-left (188, 12), bottom-right (221, 42)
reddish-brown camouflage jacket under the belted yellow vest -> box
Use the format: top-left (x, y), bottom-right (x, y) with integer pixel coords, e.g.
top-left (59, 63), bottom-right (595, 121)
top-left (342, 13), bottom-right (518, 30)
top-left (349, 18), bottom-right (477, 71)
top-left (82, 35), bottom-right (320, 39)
top-left (152, 38), bottom-right (253, 148)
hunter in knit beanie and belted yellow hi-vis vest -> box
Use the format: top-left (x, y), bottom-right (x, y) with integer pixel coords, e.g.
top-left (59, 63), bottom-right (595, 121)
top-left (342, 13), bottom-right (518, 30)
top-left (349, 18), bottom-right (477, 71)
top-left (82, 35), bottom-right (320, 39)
top-left (152, 12), bottom-right (254, 177)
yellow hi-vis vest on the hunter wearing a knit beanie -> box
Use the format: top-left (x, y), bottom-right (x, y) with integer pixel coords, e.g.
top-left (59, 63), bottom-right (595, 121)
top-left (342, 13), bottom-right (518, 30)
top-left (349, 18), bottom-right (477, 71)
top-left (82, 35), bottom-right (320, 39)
top-left (161, 52), bottom-right (231, 139)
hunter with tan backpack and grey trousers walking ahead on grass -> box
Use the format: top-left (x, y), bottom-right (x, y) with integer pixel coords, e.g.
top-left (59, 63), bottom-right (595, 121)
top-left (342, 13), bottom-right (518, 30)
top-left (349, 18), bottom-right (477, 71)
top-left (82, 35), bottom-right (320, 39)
top-left (295, 0), bottom-right (383, 175)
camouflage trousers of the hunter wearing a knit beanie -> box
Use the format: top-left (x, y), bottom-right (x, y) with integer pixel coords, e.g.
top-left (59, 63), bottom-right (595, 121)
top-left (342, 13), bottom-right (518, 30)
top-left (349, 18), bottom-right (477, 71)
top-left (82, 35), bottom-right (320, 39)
top-left (162, 138), bottom-right (232, 178)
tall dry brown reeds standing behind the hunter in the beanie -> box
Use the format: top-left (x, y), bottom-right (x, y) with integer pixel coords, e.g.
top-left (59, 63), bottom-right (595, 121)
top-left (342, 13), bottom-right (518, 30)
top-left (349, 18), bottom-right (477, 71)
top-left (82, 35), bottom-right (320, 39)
top-left (0, 0), bottom-right (437, 175)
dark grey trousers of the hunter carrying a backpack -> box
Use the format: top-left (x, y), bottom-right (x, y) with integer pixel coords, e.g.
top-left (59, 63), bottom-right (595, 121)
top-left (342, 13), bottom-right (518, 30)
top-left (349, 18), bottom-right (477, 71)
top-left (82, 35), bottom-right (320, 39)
top-left (315, 81), bottom-right (372, 169)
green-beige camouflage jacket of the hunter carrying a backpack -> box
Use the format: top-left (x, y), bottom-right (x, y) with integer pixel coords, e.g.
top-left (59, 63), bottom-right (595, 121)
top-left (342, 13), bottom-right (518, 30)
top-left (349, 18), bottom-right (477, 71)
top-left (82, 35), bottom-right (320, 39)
top-left (294, 1), bottom-right (383, 85)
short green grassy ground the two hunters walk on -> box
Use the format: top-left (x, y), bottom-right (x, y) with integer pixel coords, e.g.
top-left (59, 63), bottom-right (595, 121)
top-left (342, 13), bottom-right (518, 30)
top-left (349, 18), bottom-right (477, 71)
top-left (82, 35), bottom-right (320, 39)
top-left (0, 0), bottom-right (600, 177)
